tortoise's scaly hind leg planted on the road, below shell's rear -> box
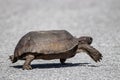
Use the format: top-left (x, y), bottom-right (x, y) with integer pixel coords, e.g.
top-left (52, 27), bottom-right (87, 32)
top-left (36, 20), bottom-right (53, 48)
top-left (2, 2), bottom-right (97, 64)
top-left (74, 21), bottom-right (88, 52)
top-left (23, 54), bottom-right (35, 70)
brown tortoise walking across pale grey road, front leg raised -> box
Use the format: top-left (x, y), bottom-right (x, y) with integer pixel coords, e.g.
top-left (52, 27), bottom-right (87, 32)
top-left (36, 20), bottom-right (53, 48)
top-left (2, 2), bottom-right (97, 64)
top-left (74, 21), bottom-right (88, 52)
top-left (10, 30), bottom-right (102, 70)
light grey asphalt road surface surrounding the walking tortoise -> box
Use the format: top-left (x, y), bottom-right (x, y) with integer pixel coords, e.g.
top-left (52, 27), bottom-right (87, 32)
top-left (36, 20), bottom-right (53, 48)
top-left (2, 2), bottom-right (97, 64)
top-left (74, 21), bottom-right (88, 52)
top-left (0, 0), bottom-right (120, 80)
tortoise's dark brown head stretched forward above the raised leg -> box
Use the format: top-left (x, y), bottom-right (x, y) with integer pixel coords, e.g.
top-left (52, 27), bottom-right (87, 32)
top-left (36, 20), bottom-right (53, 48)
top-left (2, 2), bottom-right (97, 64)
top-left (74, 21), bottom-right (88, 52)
top-left (78, 36), bottom-right (93, 45)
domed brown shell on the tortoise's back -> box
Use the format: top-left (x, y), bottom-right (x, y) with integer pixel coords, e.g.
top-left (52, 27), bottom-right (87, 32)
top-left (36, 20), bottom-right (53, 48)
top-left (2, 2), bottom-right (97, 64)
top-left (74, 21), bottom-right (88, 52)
top-left (14, 30), bottom-right (78, 57)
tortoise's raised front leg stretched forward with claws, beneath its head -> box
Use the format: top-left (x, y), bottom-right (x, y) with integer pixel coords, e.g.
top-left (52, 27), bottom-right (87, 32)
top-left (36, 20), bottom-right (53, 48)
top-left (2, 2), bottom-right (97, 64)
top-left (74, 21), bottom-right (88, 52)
top-left (80, 44), bottom-right (103, 62)
